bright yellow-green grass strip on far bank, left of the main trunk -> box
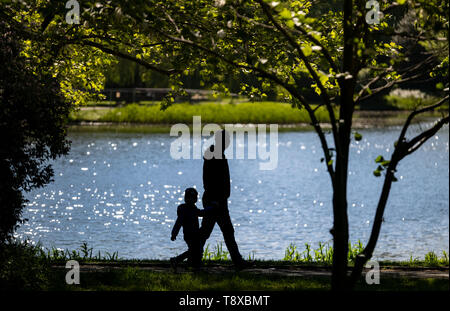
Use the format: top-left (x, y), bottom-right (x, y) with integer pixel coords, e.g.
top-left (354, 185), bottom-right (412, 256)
top-left (71, 101), bottom-right (329, 124)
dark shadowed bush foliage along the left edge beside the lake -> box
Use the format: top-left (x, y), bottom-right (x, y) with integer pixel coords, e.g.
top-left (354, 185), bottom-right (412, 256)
top-left (0, 21), bottom-right (70, 242)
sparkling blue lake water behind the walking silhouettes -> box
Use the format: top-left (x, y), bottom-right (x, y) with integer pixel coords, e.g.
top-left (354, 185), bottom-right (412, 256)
top-left (17, 125), bottom-right (449, 260)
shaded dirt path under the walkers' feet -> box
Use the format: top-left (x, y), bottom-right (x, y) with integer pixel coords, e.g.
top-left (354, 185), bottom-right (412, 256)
top-left (53, 264), bottom-right (449, 279)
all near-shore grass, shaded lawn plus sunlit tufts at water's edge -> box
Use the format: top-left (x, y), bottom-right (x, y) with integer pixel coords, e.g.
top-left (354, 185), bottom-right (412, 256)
top-left (0, 241), bottom-right (449, 291)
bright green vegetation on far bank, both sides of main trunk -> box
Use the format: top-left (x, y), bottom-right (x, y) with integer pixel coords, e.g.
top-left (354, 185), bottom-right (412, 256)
top-left (70, 93), bottom-right (448, 127)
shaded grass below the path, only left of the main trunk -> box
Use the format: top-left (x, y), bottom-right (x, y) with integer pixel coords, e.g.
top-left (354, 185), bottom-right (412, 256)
top-left (48, 267), bottom-right (329, 291)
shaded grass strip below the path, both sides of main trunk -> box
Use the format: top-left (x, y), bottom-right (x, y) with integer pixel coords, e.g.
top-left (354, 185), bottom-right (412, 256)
top-left (49, 267), bottom-right (449, 291)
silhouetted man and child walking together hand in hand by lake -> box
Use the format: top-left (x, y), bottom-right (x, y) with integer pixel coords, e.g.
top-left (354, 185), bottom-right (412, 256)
top-left (170, 130), bottom-right (249, 269)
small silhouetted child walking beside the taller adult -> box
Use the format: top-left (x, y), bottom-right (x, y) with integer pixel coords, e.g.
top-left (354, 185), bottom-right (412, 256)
top-left (170, 188), bottom-right (205, 268)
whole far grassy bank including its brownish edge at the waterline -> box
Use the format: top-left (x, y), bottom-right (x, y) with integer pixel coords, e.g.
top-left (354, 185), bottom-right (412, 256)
top-left (70, 96), bottom-right (440, 133)
